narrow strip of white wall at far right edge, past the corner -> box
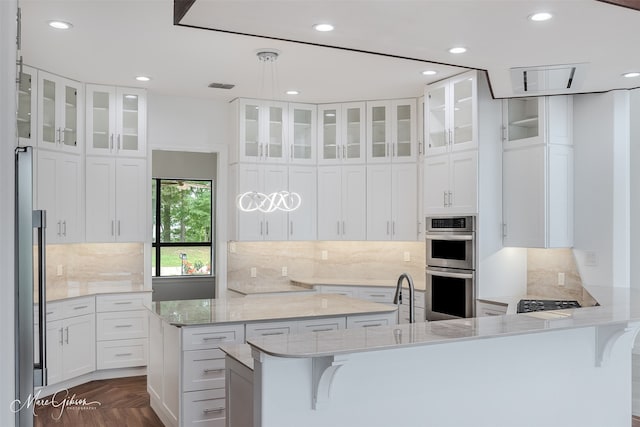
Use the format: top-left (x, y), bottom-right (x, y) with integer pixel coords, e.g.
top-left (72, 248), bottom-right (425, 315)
top-left (629, 89), bottom-right (640, 292)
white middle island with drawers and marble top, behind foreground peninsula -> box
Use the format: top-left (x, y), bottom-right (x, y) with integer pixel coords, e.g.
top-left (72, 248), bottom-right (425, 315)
top-left (147, 292), bottom-right (397, 426)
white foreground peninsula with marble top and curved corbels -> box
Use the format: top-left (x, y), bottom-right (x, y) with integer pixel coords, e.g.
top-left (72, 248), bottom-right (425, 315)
top-left (249, 288), bottom-right (640, 427)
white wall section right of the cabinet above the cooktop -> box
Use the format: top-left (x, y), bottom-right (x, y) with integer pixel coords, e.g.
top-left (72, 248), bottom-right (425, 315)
top-left (574, 91), bottom-right (630, 287)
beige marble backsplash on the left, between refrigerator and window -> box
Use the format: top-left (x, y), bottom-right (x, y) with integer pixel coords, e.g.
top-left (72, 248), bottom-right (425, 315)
top-left (47, 243), bottom-right (144, 290)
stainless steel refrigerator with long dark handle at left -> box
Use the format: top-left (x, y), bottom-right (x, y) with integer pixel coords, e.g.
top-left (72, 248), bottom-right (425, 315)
top-left (15, 147), bottom-right (47, 427)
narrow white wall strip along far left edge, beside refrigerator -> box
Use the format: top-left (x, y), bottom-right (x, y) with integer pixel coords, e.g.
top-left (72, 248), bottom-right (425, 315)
top-left (0, 0), bottom-right (17, 426)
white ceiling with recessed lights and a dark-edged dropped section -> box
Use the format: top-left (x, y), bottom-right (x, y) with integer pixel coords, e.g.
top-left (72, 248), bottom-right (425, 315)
top-left (20, 0), bottom-right (640, 103)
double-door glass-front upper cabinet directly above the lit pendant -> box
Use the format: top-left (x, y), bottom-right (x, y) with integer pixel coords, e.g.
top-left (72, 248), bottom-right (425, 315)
top-left (236, 99), bottom-right (288, 163)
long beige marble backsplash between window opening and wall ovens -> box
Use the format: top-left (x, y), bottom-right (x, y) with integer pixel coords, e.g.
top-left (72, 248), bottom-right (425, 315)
top-left (227, 241), bottom-right (425, 284)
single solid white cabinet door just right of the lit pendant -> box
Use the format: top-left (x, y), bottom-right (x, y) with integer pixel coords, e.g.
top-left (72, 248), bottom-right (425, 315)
top-left (286, 166), bottom-right (318, 240)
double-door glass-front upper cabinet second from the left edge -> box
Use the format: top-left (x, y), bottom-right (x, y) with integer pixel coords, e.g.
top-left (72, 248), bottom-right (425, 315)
top-left (37, 71), bottom-right (84, 153)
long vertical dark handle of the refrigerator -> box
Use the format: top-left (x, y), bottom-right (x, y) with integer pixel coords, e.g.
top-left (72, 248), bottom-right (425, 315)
top-left (33, 210), bottom-right (47, 386)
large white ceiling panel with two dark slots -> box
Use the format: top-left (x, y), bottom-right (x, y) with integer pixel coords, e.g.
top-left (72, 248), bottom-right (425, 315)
top-left (511, 64), bottom-right (585, 95)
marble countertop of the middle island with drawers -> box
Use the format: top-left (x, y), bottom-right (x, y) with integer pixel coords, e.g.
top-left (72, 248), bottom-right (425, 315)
top-left (150, 293), bottom-right (397, 326)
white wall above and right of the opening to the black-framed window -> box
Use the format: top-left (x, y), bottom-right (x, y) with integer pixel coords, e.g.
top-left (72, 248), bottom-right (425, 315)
top-left (147, 94), bottom-right (231, 293)
